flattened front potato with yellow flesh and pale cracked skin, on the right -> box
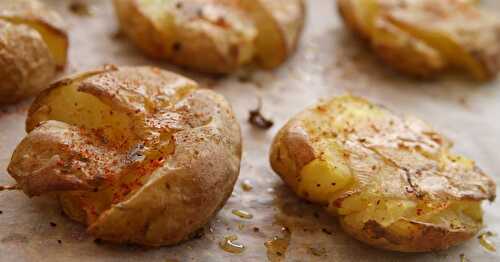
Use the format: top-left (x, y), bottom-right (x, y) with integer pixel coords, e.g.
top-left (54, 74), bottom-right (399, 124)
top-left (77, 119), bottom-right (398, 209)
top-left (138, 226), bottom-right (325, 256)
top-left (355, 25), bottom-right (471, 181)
top-left (270, 96), bottom-right (496, 252)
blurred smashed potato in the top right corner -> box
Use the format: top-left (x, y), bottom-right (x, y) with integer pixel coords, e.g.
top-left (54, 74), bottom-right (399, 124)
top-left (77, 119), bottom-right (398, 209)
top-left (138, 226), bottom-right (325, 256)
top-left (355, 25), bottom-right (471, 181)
top-left (337, 0), bottom-right (500, 80)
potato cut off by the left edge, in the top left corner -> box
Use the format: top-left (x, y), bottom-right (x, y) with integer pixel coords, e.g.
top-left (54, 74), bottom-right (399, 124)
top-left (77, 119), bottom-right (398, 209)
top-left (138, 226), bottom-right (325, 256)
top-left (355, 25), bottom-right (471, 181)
top-left (0, 0), bottom-right (68, 104)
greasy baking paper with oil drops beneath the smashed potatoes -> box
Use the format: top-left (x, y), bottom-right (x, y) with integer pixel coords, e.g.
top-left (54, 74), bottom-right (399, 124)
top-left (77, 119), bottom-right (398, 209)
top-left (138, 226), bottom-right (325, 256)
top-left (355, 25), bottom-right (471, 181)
top-left (0, 0), bottom-right (500, 262)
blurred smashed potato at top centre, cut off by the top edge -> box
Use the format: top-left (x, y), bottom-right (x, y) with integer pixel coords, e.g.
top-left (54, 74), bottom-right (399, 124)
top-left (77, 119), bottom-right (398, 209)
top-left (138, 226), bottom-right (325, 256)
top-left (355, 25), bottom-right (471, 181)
top-left (113, 0), bottom-right (305, 73)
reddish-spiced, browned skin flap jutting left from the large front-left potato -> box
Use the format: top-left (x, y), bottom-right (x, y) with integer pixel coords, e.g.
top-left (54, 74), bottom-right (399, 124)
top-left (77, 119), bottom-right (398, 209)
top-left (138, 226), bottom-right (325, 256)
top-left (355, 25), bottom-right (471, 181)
top-left (9, 120), bottom-right (123, 197)
